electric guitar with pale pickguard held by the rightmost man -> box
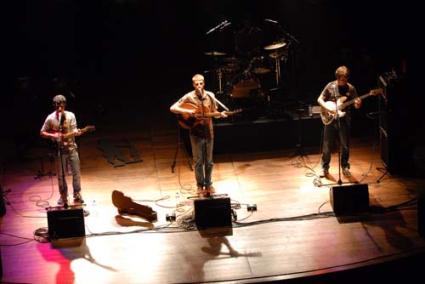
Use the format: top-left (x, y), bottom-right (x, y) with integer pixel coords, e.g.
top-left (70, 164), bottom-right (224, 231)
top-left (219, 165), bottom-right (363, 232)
top-left (320, 88), bottom-right (382, 125)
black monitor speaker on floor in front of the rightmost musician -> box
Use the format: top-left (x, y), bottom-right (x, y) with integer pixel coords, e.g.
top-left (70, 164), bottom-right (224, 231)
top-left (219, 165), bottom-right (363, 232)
top-left (330, 184), bottom-right (369, 216)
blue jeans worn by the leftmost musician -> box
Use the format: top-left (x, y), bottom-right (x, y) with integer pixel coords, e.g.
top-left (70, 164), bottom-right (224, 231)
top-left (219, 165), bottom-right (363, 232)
top-left (57, 149), bottom-right (81, 196)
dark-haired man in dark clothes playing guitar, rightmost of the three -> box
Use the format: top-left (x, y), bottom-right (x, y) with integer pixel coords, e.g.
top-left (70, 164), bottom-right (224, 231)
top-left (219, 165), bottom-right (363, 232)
top-left (317, 66), bottom-right (362, 177)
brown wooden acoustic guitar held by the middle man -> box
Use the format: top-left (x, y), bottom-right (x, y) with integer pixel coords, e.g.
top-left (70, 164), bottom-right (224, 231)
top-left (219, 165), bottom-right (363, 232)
top-left (177, 103), bottom-right (242, 129)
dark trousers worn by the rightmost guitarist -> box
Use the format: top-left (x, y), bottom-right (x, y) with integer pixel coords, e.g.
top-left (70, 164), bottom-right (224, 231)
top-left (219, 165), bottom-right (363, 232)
top-left (321, 117), bottom-right (350, 169)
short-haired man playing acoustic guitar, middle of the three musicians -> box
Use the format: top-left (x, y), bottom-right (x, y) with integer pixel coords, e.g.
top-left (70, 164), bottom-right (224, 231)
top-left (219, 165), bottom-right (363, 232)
top-left (170, 74), bottom-right (227, 196)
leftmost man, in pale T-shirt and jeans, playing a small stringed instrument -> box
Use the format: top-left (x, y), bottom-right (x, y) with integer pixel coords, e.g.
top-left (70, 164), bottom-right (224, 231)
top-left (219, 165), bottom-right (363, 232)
top-left (40, 95), bottom-right (84, 206)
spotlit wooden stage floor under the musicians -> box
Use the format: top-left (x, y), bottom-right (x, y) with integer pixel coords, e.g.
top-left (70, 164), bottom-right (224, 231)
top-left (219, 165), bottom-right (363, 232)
top-left (0, 127), bottom-right (425, 283)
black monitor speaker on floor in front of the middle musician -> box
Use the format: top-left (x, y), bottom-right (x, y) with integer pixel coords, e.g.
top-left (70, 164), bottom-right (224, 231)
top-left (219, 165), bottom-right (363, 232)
top-left (195, 197), bottom-right (232, 230)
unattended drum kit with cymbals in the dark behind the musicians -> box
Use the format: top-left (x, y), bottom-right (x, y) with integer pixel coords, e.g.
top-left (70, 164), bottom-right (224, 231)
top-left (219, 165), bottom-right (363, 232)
top-left (204, 17), bottom-right (299, 119)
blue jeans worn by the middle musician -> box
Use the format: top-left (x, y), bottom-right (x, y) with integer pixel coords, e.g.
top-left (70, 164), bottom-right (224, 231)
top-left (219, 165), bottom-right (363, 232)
top-left (190, 135), bottom-right (214, 186)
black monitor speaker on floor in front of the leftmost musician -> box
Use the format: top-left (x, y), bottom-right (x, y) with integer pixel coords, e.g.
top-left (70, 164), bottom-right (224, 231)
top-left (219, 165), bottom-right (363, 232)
top-left (47, 208), bottom-right (86, 240)
